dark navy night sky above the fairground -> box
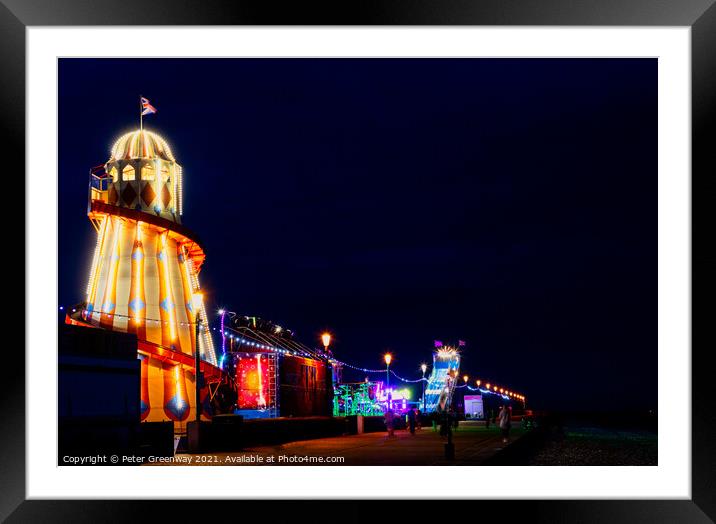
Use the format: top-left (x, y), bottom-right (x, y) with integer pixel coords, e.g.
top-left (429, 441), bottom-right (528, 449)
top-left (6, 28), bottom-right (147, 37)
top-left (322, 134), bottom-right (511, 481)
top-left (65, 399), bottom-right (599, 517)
top-left (58, 59), bottom-right (657, 410)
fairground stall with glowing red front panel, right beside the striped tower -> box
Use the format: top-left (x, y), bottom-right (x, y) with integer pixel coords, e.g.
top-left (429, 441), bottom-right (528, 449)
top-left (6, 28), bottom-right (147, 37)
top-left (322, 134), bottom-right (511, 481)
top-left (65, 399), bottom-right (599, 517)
top-left (219, 311), bottom-right (332, 418)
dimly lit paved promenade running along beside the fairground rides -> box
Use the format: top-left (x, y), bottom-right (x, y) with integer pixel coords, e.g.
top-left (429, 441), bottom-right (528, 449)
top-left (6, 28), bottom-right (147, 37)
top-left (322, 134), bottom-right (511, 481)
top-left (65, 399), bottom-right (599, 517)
top-left (155, 422), bottom-right (522, 466)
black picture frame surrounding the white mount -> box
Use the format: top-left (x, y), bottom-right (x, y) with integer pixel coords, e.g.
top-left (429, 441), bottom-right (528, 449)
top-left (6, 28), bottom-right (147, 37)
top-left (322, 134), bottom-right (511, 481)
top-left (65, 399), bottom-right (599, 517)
top-left (5, 0), bottom-right (716, 522)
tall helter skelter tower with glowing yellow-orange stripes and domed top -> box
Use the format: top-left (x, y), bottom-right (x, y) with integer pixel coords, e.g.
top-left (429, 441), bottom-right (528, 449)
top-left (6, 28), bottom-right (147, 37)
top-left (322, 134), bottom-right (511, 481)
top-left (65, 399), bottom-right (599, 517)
top-left (74, 129), bottom-right (218, 426)
